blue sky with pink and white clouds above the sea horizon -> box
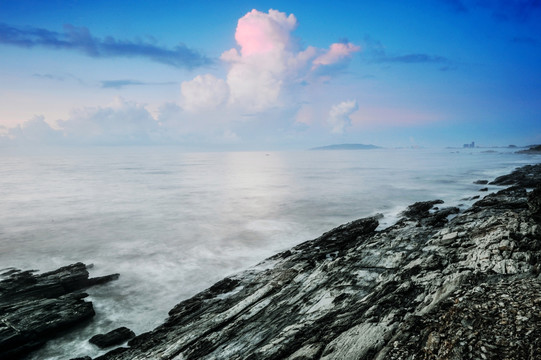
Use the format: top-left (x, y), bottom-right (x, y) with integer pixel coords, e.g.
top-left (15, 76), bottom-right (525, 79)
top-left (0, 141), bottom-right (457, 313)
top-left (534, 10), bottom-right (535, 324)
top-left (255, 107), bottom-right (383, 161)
top-left (0, 0), bottom-right (541, 151)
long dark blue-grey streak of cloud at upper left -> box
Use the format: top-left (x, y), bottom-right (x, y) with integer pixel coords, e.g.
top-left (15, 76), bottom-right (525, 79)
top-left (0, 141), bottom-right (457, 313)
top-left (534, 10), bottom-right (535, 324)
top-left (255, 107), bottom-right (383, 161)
top-left (0, 23), bottom-right (212, 69)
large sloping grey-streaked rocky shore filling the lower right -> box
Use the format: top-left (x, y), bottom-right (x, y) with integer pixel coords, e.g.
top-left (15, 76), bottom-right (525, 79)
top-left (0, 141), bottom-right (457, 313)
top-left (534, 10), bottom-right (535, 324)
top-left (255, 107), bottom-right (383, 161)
top-left (87, 165), bottom-right (541, 360)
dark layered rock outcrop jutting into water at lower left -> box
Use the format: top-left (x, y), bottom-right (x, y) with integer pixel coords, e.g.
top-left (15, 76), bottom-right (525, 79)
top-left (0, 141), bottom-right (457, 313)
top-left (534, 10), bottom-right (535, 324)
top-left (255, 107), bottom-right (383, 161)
top-left (0, 263), bottom-right (118, 359)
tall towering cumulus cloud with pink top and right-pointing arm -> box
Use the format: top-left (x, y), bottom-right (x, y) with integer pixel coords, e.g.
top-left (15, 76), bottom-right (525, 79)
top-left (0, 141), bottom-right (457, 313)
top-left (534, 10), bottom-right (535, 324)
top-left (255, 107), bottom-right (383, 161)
top-left (179, 9), bottom-right (360, 114)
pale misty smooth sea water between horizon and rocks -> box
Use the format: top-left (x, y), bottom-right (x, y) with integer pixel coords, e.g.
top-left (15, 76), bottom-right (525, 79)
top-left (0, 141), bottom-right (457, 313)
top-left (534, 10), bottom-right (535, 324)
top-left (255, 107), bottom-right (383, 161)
top-left (0, 147), bottom-right (539, 359)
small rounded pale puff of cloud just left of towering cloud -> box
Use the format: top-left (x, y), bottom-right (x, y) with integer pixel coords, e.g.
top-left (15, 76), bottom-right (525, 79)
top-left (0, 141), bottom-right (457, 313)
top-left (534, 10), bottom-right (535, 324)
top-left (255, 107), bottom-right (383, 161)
top-left (180, 74), bottom-right (229, 111)
